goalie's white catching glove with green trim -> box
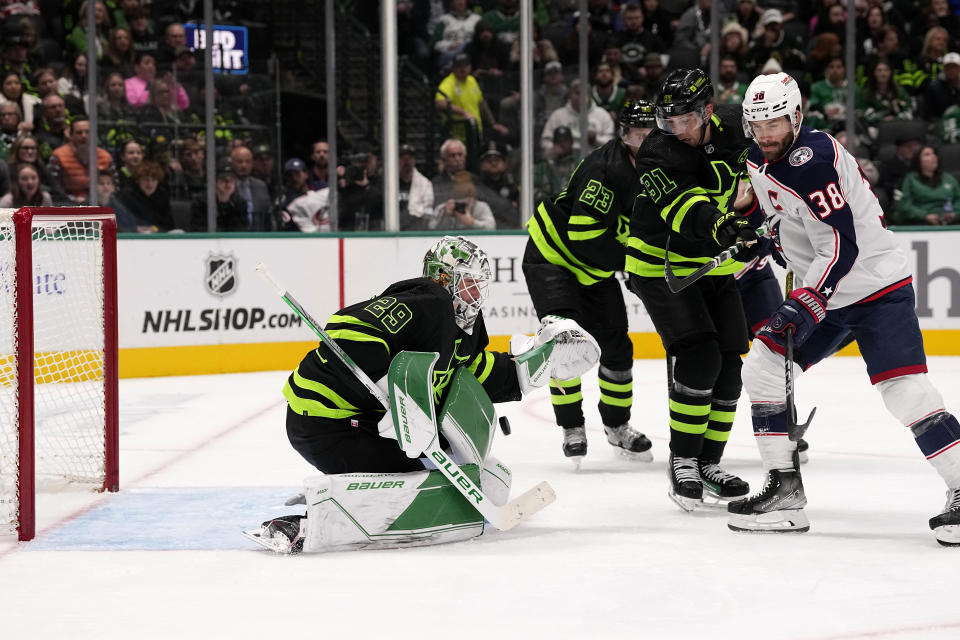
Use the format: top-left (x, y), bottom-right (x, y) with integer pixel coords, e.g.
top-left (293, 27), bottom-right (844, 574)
top-left (510, 316), bottom-right (600, 393)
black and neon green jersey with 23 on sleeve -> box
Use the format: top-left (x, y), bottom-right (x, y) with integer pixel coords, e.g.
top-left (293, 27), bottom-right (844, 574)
top-left (527, 138), bottom-right (641, 285)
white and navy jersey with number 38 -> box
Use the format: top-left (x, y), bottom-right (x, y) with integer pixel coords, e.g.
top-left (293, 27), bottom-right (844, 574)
top-left (747, 127), bottom-right (911, 309)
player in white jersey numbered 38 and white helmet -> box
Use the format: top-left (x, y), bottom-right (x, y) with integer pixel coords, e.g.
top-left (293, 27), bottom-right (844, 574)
top-left (728, 73), bottom-right (960, 546)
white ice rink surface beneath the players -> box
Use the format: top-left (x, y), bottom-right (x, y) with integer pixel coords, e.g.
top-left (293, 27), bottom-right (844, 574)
top-left (0, 358), bottom-right (960, 640)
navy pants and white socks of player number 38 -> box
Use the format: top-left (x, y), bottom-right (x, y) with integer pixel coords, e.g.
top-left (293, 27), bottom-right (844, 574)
top-left (743, 283), bottom-right (960, 487)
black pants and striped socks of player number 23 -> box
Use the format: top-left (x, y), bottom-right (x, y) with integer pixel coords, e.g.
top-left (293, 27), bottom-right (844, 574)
top-left (523, 248), bottom-right (633, 427)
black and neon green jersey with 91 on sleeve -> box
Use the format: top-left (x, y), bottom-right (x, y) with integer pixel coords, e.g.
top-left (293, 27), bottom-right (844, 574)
top-left (626, 105), bottom-right (751, 278)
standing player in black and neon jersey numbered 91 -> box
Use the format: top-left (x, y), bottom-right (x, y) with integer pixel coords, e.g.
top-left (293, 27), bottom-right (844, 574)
top-left (626, 69), bottom-right (757, 511)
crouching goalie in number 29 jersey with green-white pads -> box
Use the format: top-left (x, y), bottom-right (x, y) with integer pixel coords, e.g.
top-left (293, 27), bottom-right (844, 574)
top-left (244, 236), bottom-right (600, 553)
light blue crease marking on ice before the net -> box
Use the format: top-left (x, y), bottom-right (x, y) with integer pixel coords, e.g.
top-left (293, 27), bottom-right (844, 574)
top-left (29, 487), bottom-right (304, 551)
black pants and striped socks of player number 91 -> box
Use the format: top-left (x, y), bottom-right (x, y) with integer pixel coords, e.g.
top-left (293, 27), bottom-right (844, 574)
top-left (630, 275), bottom-right (747, 461)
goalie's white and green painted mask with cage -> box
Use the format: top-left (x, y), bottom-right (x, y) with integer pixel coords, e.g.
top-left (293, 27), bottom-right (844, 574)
top-left (423, 236), bottom-right (492, 333)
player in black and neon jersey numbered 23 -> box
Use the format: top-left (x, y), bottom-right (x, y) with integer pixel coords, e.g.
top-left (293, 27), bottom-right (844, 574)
top-left (523, 101), bottom-right (655, 465)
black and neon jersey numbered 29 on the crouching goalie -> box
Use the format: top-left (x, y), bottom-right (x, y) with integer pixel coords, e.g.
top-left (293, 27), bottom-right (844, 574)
top-left (283, 278), bottom-right (521, 433)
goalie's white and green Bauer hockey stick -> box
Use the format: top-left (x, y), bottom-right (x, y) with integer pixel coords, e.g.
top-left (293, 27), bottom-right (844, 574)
top-left (256, 262), bottom-right (557, 531)
